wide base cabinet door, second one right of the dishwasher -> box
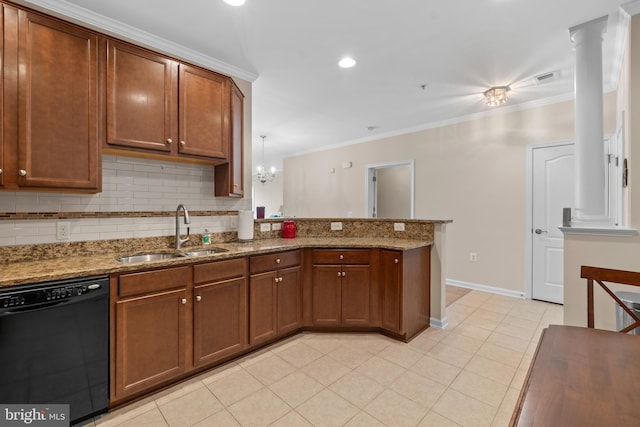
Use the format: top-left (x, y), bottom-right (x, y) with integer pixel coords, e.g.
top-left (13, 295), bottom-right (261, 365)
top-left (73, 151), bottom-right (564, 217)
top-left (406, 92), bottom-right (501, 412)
top-left (193, 278), bottom-right (247, 366)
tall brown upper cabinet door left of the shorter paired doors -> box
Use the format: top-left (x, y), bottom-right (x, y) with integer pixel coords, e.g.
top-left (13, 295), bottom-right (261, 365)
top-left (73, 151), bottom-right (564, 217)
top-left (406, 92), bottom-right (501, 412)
top-left (18, 10), bottom-right (101, 191)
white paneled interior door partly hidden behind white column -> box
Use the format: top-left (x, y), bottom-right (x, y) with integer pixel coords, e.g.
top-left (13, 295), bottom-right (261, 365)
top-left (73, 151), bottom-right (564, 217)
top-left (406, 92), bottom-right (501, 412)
top-left (531, 144), bottom-right (575, 304)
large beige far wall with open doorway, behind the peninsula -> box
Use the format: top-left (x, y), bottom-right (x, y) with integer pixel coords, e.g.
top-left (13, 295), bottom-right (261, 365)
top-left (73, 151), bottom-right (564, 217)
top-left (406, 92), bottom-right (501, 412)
top-left (284, 94), bottom-right (615, 292)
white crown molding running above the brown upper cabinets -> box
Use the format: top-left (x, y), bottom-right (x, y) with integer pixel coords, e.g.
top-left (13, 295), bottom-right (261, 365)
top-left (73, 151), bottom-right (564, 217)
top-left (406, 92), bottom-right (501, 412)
top-left (16, 0), bottom-right (258, 82)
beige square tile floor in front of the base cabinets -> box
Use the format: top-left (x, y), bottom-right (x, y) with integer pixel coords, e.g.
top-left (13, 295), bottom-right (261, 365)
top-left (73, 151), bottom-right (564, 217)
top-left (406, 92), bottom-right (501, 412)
top-left (90, 291), bottom-right (563, 427)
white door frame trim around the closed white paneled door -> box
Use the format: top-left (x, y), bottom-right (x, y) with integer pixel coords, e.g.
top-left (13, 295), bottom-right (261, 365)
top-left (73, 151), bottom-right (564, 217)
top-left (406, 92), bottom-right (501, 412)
top-left (524, 139), bottom-right (575, 299)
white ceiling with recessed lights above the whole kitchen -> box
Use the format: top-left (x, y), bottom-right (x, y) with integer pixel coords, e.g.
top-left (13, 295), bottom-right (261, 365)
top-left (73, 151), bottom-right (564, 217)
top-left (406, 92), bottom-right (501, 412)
top-left (19, 0), bottom-right (626, 166)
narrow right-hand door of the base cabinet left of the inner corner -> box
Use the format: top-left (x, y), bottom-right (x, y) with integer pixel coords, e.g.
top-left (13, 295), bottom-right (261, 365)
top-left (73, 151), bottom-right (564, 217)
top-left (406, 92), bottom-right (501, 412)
top-left (277, 267), bottom-right (302, 334)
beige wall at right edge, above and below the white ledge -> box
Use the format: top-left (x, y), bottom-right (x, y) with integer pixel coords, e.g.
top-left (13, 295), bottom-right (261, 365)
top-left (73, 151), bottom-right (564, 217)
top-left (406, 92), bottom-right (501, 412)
top-left (564, 15), bottom-right (640, 329)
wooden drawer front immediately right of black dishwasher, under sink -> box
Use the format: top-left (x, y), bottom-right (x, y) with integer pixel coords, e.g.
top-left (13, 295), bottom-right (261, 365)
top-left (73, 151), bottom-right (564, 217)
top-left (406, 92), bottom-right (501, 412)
top-left (118, 267), bottom-right (191, 297)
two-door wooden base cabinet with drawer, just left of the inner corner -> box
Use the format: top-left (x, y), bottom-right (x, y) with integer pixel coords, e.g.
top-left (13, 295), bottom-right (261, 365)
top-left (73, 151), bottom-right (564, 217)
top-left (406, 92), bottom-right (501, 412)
top-left (249, 250), bottom-right (302, 345)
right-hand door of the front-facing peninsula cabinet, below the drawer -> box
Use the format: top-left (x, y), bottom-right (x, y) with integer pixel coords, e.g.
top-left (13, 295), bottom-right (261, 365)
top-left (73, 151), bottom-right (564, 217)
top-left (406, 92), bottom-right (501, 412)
top-left (342, 265), bottom-right (370, 326)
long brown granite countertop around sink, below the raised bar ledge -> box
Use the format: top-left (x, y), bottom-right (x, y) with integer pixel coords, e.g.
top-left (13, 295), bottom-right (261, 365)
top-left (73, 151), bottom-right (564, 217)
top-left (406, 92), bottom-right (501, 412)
top-left (0, 237), bottom-right (433, 287)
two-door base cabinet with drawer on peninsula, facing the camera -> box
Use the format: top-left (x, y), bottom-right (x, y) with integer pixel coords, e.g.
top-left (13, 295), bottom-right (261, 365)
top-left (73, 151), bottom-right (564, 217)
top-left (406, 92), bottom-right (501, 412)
top-left (312, 249), bottom-right (371, 326)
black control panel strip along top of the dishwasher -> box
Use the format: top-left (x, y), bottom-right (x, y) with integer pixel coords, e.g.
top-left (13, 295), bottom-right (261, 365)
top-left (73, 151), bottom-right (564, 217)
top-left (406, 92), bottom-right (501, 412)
top-left (0, 279), bottom-right (108, 309)
